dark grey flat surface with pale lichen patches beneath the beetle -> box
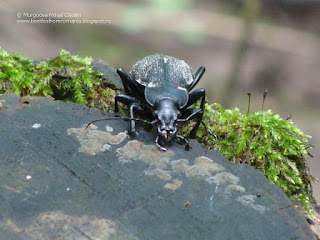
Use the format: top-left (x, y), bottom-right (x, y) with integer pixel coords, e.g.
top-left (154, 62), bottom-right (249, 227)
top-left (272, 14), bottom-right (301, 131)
top-left (0, 95), bottom-right (316, 240)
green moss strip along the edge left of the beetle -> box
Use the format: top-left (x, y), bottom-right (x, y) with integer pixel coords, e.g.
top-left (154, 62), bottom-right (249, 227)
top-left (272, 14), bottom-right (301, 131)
top-left (0, 48), bottom-right (115, 111)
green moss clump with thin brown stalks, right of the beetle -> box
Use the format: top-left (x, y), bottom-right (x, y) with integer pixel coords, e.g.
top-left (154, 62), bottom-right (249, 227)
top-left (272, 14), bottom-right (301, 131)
top-left (184, 104), bottom-right (314, 212)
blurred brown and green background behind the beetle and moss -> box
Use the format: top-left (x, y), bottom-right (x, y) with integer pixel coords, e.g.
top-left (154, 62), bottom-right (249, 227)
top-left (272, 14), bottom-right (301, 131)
top-left (0, 0), bottom-right (320, 201)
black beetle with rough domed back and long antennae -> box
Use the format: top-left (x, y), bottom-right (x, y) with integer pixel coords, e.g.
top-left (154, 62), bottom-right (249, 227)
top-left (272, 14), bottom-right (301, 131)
top-left (87, 54), bottom-right (215, 151)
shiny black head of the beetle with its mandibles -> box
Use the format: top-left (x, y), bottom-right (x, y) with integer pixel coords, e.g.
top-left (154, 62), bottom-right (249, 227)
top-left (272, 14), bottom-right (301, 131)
top-left (153, 98), bottom-right (180, 142)
